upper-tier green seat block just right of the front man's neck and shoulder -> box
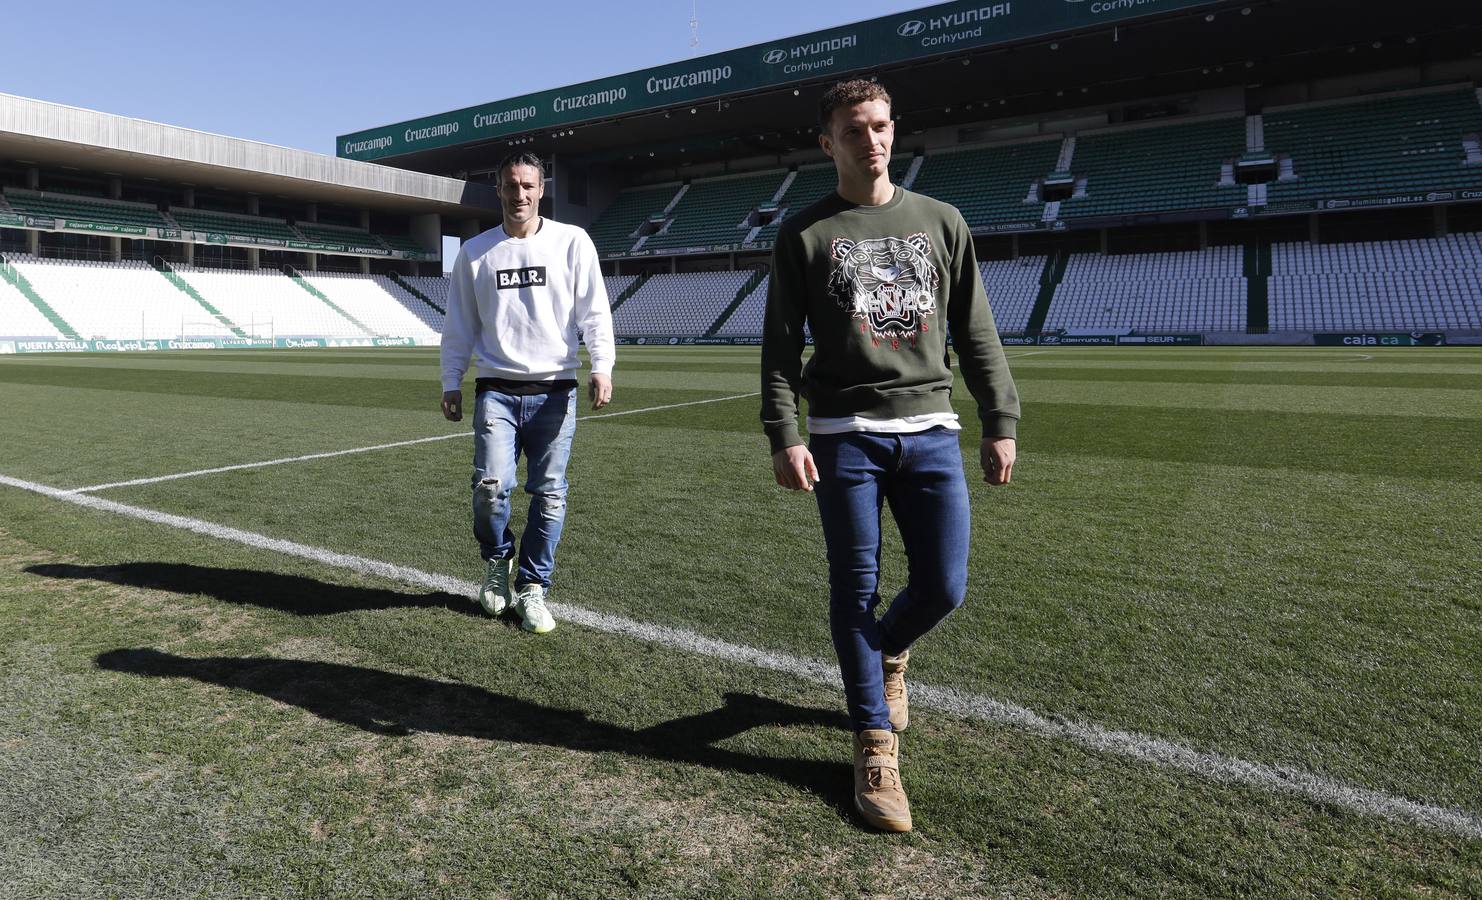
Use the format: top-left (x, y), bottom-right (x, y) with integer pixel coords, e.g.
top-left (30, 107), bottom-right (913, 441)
top-left (913, 139), bottom-right (1061, 228)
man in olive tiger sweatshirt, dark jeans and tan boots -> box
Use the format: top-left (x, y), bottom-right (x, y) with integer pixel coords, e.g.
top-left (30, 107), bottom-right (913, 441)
top-left (762, 80), bottom-right (1020, 832)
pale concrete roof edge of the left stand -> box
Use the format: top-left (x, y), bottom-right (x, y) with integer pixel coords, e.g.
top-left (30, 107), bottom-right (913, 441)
top-left (0, 93), bottom-right (499, 216)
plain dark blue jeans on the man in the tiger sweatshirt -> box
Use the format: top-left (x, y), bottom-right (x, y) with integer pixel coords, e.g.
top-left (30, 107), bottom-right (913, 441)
top-left (808, 429), bottom-right (971, 731)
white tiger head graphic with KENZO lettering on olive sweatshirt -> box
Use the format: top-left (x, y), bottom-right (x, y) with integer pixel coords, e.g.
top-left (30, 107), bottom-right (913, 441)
top-left (828, 234), bottom-right (941, 348)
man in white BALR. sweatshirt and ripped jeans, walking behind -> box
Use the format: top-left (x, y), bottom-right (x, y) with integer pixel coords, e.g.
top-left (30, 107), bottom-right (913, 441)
top-left (442, 153), bottom-right (614, 635)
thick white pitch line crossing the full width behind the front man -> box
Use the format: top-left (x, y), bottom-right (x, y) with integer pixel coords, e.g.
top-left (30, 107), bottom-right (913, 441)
top-left (0, 474), bottom-right (1482, 839)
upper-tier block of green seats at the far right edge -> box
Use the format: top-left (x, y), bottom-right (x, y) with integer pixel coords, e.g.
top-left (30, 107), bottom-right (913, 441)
top-left (1263, 87), bottom-right (1482, 205)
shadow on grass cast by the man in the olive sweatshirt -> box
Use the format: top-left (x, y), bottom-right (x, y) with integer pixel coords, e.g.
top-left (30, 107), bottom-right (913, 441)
top-left (98, 648), bottom-right (852, 817)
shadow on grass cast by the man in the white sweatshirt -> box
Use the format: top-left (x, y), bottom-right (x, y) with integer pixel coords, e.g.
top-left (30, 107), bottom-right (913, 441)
top-left (25, 562), bottom-right (482, 615)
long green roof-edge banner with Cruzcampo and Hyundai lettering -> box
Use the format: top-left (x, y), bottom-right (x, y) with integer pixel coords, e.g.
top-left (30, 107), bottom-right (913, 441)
top-left (335, 0), bottom-right (1218, 160)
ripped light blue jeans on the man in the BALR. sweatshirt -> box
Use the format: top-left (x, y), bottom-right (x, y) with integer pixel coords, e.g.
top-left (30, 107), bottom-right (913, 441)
top-left (473, 388), bottom-right (576, 587)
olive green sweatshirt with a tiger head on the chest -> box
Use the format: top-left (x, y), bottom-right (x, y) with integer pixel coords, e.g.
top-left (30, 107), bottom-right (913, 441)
top-left (762, 187), bottom-right (1020, 452)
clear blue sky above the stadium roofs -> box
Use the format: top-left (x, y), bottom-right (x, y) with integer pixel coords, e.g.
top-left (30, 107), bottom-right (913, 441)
top-left (0, 0), bottom-right (929, 153)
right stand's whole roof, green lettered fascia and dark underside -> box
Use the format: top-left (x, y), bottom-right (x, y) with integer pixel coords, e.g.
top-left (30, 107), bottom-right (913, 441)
top-left (336, 0), bottom-right (1482, 173)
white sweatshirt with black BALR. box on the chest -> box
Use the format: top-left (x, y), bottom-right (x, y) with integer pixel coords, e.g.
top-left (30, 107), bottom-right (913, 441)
top-left (442, 218), bottom-right (614, 391)
